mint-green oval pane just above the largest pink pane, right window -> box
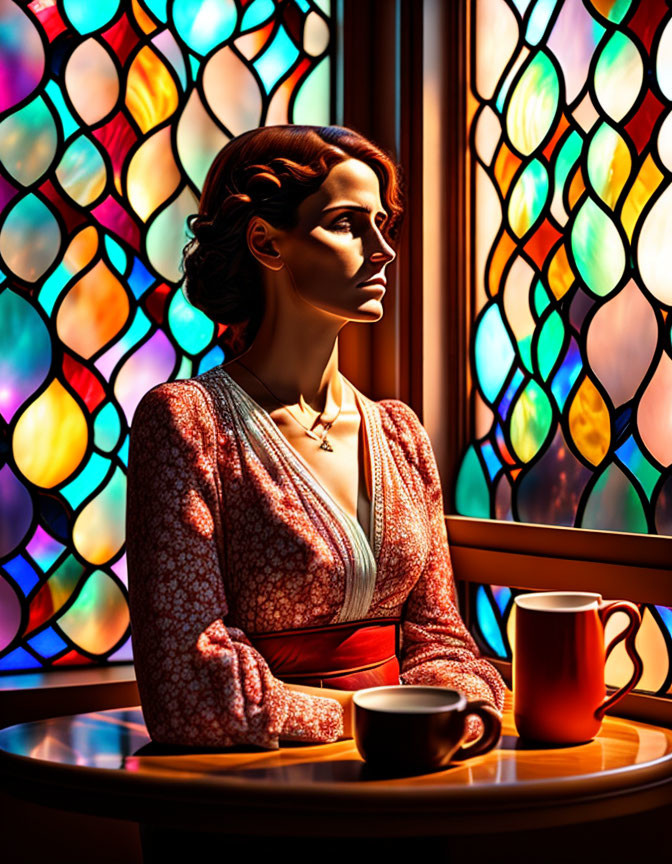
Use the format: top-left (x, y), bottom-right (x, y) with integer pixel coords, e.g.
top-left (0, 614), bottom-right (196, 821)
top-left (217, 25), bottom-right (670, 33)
top-left (572, 198), bottom-right (625, 297)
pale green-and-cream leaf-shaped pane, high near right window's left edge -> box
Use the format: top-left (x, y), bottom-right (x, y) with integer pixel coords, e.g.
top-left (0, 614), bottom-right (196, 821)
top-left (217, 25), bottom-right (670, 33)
top-left (506, 51), bottom-right (560, 156)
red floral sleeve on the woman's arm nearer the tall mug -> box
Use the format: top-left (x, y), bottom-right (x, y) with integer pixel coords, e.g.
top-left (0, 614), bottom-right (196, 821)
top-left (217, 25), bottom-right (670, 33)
top-left (384, 401), bottom-right (505, 719)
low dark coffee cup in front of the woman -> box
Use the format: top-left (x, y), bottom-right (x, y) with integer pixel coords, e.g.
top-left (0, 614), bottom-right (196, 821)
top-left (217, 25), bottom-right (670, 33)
top-left (353, 684), bottom-right (501, 771)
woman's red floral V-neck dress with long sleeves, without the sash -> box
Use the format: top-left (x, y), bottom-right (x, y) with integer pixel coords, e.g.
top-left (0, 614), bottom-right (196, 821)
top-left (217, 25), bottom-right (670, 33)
top-left (126, 367), bottom-right (504, 748)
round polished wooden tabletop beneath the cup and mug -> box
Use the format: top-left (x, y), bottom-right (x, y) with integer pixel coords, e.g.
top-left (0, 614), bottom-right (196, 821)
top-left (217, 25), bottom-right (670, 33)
top-left (0, 694), bottom-right (672, 836)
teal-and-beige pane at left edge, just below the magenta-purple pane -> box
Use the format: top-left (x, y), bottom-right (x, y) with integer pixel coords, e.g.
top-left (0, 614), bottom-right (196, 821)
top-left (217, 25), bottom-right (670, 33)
top-left (0, 96), bottom-right (58, 186)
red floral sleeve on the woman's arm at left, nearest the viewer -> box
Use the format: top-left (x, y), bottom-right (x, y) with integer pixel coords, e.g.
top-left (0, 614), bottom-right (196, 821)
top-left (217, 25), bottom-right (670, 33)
top-left (126, 382), bottom-right (343, 748)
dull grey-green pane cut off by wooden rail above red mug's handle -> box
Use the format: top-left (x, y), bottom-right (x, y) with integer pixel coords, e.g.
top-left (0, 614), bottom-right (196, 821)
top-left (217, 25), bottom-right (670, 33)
top-left (581, 463), bottom-right (648, 534)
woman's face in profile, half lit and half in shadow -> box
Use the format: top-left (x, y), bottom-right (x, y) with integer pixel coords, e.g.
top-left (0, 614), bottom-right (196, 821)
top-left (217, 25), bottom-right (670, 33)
top-left (275, 159), bottom-right (396, 321)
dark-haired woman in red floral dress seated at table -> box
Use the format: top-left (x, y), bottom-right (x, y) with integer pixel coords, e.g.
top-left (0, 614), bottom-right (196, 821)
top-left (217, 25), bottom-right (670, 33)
top-left (127, 126), bottom-right (504, 748)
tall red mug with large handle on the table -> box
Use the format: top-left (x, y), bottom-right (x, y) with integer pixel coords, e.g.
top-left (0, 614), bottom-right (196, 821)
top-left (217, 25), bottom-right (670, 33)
top-left (513, 591), bottom-right (642, 744)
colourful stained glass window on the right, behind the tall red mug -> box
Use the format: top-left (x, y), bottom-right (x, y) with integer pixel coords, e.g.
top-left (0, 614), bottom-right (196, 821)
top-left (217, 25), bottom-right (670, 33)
top-left (462, 0), bottom-right (672, 693)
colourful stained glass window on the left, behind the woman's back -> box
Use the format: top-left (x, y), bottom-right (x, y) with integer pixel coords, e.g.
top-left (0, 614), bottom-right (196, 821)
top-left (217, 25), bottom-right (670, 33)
top-left (0, 0), bottom-right (333, 672)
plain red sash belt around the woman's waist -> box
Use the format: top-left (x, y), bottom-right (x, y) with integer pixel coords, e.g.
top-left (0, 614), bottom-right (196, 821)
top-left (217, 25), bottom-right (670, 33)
top-left (248, 618), bottom-right (399, 690)
